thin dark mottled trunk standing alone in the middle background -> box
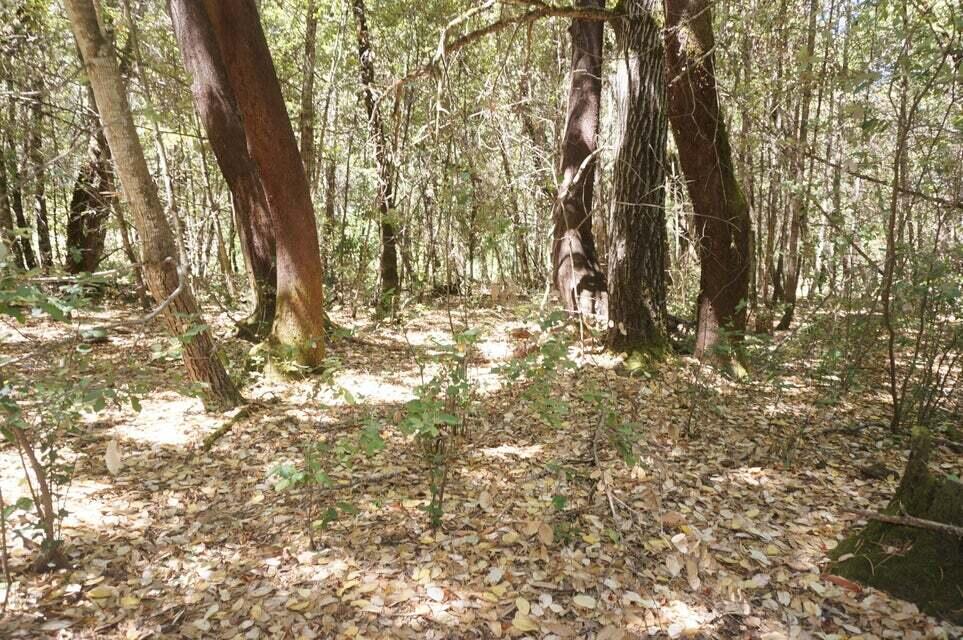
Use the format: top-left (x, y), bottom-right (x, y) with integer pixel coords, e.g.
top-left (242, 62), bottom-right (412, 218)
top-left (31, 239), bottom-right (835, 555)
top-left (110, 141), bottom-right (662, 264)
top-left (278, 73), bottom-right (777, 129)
top-left (352, 0), bottom-right (401, 311)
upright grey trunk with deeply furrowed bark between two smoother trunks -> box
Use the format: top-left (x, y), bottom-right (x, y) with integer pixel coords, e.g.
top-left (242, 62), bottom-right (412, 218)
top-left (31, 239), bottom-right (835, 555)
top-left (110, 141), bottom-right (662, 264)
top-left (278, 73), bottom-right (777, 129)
top-left (608, 0), bottom-right (668, 351)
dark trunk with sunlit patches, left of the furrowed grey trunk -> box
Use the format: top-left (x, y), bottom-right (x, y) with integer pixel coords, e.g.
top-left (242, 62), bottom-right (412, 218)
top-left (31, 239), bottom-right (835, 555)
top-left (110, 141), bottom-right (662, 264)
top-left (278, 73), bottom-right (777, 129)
top-left (552, 0), bottom-right (605, 315)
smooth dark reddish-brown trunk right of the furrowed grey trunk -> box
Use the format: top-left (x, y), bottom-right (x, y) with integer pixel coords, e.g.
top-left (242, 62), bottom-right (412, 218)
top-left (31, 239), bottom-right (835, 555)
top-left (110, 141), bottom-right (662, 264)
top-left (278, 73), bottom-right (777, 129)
top-left (665, 0), bottom-right (751, 358)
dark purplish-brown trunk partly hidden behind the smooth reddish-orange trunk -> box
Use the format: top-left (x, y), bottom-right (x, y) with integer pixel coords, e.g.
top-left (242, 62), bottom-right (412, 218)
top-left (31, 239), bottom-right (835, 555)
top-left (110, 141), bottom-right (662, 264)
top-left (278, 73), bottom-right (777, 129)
top-left (168, 0), bottom-right (277, 341)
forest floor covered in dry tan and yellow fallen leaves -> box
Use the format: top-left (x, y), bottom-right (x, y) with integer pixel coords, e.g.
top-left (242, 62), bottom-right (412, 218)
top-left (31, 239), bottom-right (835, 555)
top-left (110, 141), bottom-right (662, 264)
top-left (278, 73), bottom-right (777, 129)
top-left (0, 298), bottom-right (963, 640)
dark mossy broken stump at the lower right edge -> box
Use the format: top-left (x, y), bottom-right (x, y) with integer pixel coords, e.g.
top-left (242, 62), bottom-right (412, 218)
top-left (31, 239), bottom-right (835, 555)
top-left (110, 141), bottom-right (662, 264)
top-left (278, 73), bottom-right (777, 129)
top-left (832, 434), bottom-right (963, 624)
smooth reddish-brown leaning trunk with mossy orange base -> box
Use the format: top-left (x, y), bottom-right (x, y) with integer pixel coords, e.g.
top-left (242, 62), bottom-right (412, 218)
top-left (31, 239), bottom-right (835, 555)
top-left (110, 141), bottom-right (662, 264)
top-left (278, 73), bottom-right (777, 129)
top-left (204, 0), bottom-right (326, 368)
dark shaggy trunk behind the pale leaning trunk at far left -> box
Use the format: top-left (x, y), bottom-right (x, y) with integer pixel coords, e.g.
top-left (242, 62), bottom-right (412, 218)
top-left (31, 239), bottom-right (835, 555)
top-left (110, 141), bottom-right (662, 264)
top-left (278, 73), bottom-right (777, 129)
top-left (64, 88), bottom-right (114, 273)
